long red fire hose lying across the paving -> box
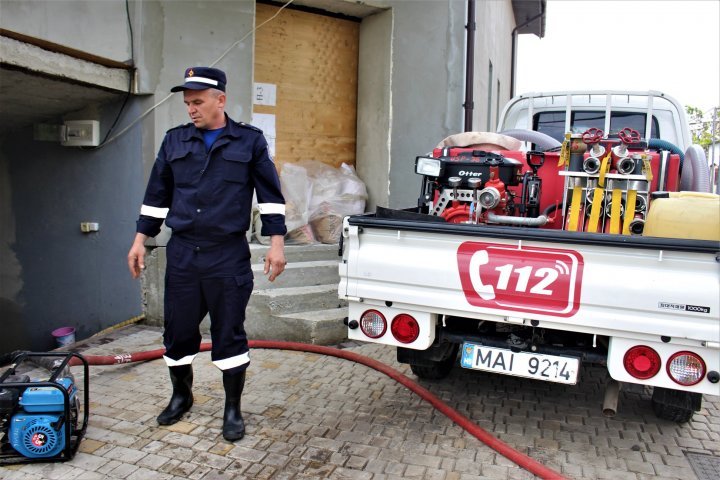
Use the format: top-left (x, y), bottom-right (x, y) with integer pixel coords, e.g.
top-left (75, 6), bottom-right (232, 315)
top-left (70, 340), bottom-right (565, 479)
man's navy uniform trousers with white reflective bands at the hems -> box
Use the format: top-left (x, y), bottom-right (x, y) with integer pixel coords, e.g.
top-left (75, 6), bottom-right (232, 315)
top-left (163, 236), bottom-right (253, 374)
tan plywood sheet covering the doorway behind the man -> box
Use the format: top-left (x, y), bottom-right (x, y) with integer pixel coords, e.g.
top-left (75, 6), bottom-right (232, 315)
top-left (253, 4), bottom-right (360, 166)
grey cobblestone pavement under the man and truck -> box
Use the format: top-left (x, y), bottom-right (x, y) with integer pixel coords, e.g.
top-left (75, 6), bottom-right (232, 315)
top-left (0, 325), bottom-right (720, 480)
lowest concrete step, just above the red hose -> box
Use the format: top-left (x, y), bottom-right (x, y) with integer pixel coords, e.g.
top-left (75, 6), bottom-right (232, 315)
top-left (250, 307), bottom-right (348, 345)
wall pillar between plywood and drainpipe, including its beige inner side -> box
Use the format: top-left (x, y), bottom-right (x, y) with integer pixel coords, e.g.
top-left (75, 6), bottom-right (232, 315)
top-left (357, 0), bottom-right (466, 211)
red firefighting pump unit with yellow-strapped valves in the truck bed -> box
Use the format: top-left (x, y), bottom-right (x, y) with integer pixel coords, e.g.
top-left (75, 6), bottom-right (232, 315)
top-left (415, 128), bottom-right (680, 234)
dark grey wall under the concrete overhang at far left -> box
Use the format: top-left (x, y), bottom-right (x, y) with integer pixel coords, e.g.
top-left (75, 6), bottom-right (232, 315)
top-left (0, 99), bottom-right (142, 352)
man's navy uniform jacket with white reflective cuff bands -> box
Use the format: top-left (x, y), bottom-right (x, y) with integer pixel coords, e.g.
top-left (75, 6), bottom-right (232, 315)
top-left (137, 115), bottom-right (287, 247)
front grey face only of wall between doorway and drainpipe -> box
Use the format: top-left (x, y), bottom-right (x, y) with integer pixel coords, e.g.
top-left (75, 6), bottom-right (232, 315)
top-left (388, 0), bottom-right (467, 208)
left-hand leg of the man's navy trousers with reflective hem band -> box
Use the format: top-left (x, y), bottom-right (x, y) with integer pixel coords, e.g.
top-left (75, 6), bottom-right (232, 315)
top-left (163, 238), bottom-right (208, 367)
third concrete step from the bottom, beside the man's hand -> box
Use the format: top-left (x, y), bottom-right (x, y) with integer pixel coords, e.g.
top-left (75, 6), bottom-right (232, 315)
top-left (252, 260), bottom-right (340, 290)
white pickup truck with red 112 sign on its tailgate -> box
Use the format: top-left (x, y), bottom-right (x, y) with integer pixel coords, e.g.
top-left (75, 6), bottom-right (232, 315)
top-left (338, 92), bottom-right (720, 422)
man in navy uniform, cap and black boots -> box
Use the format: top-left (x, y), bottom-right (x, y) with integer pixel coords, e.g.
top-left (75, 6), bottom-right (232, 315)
top-left (128, 67), bottom-right (287, 441)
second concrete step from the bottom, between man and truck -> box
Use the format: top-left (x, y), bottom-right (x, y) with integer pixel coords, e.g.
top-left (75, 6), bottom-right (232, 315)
top-left (247, 283), bottom-right (347, 318)
